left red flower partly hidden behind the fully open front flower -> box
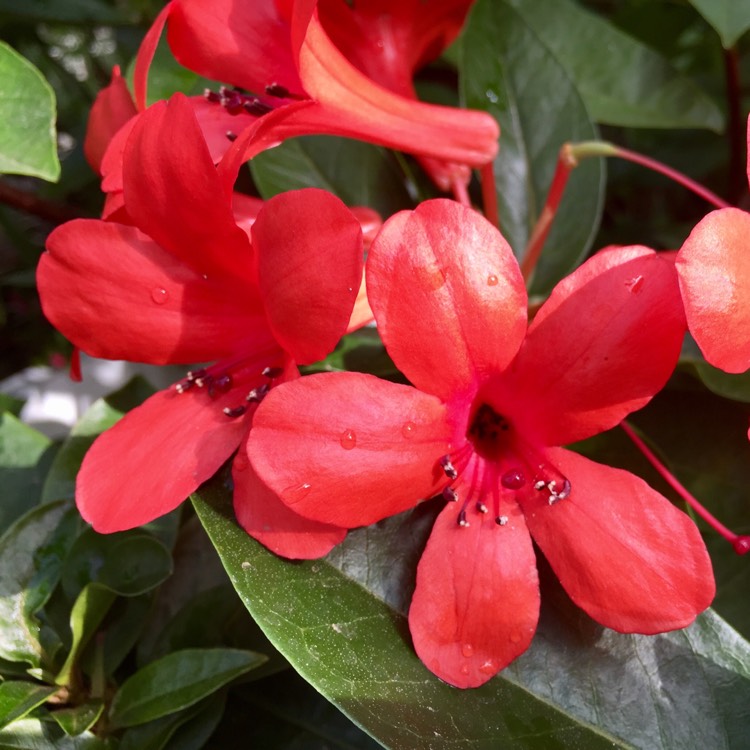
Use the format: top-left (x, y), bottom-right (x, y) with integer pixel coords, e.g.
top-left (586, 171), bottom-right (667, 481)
top-left (38, 95), bottom-right (374, 557)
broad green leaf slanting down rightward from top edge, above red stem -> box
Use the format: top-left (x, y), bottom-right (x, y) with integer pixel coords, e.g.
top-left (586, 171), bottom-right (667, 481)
top-left (502, 0), bottom-right (724, 132)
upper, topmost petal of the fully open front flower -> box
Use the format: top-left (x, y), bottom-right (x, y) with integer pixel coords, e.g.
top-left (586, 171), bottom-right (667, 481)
top-left (367, 200), bottom-right (526, 400)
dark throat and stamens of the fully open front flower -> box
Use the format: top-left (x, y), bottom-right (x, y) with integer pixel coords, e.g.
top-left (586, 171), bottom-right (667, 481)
top-left (439, 402), bottom-right (571, 527)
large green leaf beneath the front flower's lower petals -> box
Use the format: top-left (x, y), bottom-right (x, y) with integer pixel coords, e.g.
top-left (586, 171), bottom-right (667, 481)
top-left (193, 480), bottom-right (750, 750)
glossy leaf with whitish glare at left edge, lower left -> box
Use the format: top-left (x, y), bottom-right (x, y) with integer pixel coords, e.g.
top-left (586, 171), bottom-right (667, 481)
top-left (0, 502), bottom-right (69, 667)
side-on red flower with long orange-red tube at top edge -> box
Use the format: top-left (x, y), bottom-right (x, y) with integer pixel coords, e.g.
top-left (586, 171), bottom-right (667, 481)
top-left (136, 0), bottom-right (499, 190)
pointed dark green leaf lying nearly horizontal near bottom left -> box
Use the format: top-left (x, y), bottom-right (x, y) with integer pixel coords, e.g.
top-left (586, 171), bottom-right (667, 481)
top-left (111, 648), bottom-right (266, 727)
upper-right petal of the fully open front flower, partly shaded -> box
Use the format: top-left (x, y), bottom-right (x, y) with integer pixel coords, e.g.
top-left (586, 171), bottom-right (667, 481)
top-left (506, 247), bottom-right (685, 445)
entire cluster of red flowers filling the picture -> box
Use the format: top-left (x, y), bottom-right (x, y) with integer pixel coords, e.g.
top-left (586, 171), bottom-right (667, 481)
top-left (38, 0), bottom-right (724, 687)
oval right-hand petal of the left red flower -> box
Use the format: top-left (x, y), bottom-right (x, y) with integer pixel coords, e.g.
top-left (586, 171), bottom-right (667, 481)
top-left (251, 188), bottom-right (363, 364)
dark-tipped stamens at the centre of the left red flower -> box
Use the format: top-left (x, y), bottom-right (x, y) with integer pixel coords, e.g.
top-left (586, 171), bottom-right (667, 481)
top-left (175, 361), bottom-right (284, 419)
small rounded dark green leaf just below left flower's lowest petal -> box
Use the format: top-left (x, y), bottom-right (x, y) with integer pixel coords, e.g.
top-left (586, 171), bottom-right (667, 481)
top-left (62, 529), bottom-right (172, 597)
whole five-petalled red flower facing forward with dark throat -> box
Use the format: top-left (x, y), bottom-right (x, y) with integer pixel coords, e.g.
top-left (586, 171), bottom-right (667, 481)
top-left (248, 200), bottom-right (714, 687)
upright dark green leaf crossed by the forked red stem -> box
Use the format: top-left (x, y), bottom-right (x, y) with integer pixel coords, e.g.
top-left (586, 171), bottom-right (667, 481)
top-left (460, 0), bottom-right (604, 294)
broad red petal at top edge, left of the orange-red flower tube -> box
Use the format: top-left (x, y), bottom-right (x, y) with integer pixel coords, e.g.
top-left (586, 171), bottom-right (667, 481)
top-left (167, 0), bottom-right (302, 94)
